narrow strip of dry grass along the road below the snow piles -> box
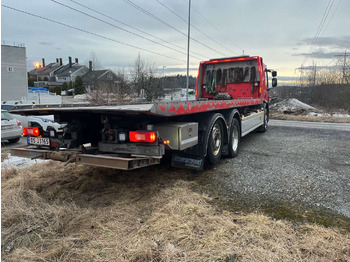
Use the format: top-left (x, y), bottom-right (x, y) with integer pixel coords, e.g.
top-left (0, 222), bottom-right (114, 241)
top-left (270, 112), bottom-right (350, 123)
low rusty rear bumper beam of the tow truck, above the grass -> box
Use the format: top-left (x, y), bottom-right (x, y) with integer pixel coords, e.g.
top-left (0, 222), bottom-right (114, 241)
top-left (11, 148), bottom-right (160, 170)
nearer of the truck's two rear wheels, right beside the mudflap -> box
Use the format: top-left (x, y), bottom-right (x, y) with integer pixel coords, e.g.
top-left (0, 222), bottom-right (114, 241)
top-left (207, 119), bottom-right (224, 165)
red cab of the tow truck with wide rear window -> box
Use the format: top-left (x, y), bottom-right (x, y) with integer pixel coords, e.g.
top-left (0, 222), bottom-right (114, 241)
top-left (196, 56), bottom-right (270, 101)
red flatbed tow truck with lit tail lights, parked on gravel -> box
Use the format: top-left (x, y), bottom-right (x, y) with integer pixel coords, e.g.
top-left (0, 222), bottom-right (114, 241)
top-left (12, 56), bottom-right (277, 170)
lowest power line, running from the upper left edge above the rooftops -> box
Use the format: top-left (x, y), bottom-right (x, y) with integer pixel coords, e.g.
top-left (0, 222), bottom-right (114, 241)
top-left (1, 4), bottom-right (186, 62)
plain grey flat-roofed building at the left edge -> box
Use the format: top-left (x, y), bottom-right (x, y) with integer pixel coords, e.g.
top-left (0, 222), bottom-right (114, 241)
top-left (1, 44), bottom-right (28, 101)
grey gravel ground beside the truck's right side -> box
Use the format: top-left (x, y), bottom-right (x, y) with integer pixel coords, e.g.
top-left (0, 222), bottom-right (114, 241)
top-left (198, 123), bottom-right (350, 217)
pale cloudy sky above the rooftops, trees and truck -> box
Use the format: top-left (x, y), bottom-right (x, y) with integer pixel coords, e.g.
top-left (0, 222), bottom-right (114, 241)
top-left (1, 0), bottom-right (350, 80)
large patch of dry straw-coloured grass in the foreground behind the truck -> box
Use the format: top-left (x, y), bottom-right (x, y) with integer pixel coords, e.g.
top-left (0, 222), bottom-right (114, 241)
top-left (1, 162), bottom-right (350, 261)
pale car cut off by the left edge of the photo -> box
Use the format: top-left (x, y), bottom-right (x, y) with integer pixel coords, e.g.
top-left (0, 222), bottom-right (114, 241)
top-left (1, 110), bottom-right (23, 143)
